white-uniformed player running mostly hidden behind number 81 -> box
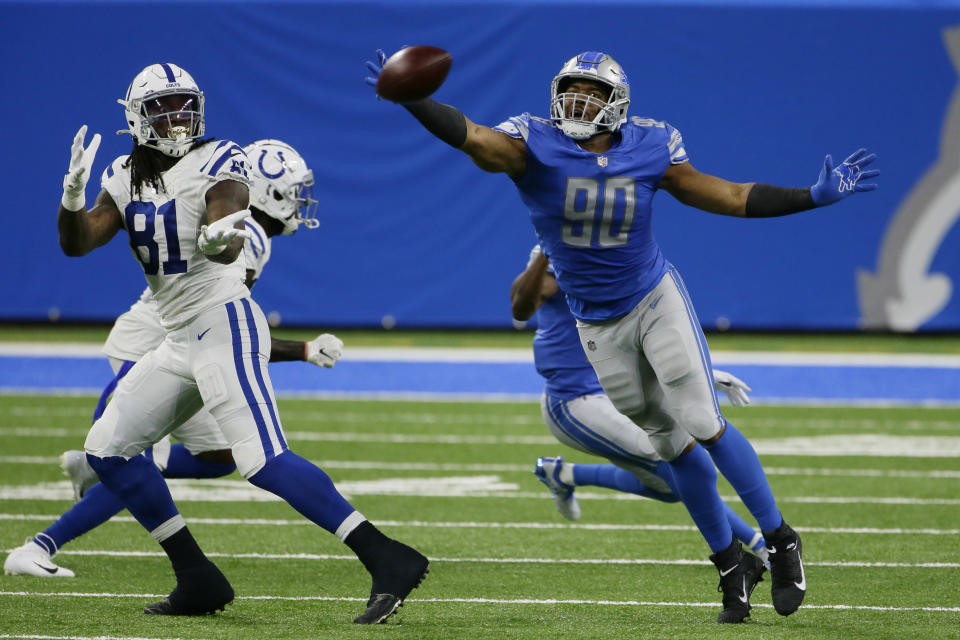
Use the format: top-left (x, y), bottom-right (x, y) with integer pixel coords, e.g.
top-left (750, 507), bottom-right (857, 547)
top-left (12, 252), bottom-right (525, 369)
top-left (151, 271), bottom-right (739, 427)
top-left (3, 140), bottom-right (343, 578)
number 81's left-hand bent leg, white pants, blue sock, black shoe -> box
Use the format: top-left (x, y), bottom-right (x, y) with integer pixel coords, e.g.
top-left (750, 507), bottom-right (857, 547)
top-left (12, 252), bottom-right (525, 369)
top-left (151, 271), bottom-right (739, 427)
top-left (84, 344), bottom-right (233, 615)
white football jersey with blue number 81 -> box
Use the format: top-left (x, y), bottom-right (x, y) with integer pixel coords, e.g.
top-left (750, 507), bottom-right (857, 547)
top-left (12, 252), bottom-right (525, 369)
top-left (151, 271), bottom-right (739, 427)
top-left (101, 140), bottom-right (250, 331)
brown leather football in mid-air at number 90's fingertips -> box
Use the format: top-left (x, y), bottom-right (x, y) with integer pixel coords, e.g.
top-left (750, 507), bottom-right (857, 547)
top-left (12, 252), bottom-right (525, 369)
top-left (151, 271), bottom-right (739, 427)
top-left (377, 45), bottom-right (453, 103)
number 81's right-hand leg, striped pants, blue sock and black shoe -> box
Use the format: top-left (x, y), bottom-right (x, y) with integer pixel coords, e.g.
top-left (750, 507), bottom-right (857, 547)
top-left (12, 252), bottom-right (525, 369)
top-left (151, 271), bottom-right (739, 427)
top-left (199, 298), bottom-right (429, 624)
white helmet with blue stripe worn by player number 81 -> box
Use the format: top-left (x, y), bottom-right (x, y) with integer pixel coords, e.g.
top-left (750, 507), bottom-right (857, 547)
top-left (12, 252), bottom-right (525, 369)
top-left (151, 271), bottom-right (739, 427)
top-left (117, 62), bottom-right (204, 158)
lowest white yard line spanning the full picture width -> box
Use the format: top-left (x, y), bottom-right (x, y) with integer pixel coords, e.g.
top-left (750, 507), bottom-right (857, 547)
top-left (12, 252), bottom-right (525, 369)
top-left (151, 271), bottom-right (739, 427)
top-left (0, 592), bottom-right (960, 616)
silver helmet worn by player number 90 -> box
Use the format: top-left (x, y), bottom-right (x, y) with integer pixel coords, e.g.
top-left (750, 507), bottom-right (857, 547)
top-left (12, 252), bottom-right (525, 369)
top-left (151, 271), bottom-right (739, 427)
top-left (550, 51), bottom-right (630, 140)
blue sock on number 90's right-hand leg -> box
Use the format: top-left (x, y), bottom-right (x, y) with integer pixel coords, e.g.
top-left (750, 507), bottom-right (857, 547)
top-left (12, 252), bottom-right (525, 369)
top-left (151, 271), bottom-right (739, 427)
top-left (706, 422), bottom-right (783, 530)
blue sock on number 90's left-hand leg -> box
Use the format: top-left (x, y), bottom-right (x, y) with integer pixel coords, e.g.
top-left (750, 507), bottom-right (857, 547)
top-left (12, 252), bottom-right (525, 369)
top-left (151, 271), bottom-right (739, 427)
top-left (670, 446), bottom-right (733, 553)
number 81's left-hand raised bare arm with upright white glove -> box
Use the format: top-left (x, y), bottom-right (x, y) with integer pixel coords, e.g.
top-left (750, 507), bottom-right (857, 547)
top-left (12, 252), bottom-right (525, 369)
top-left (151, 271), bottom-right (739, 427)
top-left (57, 125), bottom-right (123, 257)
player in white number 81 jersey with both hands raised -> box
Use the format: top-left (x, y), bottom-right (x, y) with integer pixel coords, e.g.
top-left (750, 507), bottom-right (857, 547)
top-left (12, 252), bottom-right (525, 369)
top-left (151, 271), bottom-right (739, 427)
top-left (57, 63), bottom-right (429, 624)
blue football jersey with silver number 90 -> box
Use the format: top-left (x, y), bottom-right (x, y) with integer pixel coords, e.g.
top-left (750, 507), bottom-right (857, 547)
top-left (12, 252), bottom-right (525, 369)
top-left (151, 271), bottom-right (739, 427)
top-left (495, 113), bottom-right (688, 322)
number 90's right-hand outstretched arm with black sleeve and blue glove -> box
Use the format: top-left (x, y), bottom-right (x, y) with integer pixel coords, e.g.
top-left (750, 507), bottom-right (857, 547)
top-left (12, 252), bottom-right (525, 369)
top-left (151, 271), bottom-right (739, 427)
top-left (660, 149), bottom-right (880, 218)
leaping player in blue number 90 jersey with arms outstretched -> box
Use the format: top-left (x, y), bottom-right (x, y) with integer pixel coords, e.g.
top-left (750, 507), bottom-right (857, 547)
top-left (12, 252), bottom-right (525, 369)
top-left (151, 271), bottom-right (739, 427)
top-left (366, 51), bottom-right (879, 622)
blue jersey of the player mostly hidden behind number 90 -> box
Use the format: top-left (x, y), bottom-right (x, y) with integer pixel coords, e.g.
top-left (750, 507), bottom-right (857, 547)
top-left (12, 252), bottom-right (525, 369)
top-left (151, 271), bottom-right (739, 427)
top-left (533, 268), bottom-right (603, 400)
